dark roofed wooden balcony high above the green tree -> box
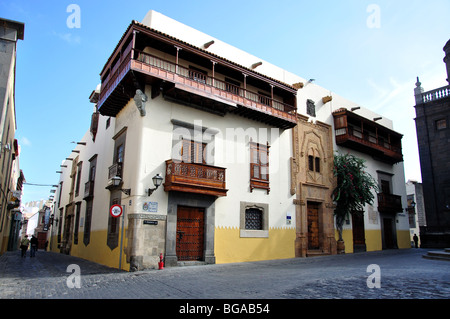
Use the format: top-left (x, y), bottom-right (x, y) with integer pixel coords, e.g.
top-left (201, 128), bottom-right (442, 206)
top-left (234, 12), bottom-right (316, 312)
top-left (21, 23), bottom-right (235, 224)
top-left (333, 109), bottom-right (403, 164)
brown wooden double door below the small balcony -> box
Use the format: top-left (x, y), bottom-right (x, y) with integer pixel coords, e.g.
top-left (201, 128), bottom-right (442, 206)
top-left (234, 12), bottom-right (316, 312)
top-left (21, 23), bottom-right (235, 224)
top-left (176, 206), bottom-right (205, 261)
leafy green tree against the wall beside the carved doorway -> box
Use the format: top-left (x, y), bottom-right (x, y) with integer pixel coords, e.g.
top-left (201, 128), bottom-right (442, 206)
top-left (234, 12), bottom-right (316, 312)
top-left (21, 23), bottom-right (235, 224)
top-left (332, 153), bottom-right (379, 252)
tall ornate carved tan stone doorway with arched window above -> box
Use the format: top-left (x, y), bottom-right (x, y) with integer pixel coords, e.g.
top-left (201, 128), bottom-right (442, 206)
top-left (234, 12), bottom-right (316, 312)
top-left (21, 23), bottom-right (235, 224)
top-left (291, 115), bottom-right (336, 257)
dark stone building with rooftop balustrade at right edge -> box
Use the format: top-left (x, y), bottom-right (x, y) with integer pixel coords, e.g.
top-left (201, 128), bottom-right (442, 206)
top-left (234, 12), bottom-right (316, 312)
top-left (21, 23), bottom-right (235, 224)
top-left (414, 40), bottom-right (450, 248)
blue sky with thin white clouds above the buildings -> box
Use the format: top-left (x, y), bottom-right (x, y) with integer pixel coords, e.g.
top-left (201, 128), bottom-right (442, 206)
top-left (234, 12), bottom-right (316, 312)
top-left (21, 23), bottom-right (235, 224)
top-left (0, 0), bottom-right (450, 202)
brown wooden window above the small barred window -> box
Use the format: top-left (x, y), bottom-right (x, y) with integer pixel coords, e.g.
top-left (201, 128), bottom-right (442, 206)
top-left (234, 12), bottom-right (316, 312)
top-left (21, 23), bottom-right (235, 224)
top-left (250, 141), bottom-right (270, 194)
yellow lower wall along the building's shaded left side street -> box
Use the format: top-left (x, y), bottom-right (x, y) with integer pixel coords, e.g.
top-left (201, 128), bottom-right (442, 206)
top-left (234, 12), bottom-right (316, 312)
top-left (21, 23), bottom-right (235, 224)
top-left (51, 230), bottom-right (130, 271)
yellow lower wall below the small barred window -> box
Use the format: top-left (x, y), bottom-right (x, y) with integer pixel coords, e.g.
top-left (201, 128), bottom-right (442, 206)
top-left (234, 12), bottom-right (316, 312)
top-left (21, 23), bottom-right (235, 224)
top-left (214, 227), bottom-right (295, 264)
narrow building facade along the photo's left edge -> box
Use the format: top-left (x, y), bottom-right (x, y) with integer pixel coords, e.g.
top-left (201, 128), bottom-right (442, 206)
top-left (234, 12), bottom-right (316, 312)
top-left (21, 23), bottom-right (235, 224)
top-left (0, 18), bottom-right (25, 254)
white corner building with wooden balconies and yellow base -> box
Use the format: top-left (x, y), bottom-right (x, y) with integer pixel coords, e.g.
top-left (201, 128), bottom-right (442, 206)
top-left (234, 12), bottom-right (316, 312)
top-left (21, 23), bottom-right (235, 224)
top-left (50, 11), bottom-right (410, 270)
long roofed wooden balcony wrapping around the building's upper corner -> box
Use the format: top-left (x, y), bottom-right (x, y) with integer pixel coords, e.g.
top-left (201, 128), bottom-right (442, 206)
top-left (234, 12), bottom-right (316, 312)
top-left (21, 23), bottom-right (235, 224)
top-left (98, 21), bottom-right (297, 129)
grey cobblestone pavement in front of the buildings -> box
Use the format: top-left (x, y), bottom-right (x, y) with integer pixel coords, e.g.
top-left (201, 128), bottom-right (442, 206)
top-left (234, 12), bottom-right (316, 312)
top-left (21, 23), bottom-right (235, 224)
top-left (0, 249), bottom-right (450, 299)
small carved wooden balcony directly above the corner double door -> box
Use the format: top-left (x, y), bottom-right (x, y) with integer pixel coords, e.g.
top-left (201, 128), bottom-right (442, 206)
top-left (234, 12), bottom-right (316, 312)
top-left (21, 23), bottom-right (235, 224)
top-left (164, 159), bottom-right (228, 196)
